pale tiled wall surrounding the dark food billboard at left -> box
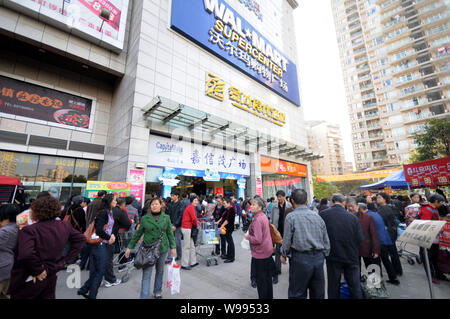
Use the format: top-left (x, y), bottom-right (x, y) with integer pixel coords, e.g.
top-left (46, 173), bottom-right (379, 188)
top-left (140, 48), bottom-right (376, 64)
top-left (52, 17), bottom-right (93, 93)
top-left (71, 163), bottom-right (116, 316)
top-left (0, 49), bottom-right (112, 160)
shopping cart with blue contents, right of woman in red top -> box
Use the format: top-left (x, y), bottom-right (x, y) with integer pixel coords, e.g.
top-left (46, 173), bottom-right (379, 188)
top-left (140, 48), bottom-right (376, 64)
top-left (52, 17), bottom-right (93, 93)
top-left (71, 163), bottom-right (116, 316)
top-left (195, 218), bottom-right (219, 267)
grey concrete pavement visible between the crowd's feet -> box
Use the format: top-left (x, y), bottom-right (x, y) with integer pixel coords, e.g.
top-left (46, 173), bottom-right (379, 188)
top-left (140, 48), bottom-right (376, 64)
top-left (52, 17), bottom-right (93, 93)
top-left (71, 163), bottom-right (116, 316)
top-left (56, 230), bottom-right (450, 299)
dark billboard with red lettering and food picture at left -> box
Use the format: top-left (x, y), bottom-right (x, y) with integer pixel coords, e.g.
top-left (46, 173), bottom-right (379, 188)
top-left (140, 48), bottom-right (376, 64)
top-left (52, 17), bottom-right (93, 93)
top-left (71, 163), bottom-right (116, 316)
top-left (0, 76), bottom-right (93, 129)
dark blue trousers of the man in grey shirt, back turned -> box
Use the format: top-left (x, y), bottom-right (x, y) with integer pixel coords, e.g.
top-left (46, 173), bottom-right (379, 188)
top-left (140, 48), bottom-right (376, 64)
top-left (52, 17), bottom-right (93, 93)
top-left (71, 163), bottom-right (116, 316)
top-left (288, 252), bottom-right (325, 299)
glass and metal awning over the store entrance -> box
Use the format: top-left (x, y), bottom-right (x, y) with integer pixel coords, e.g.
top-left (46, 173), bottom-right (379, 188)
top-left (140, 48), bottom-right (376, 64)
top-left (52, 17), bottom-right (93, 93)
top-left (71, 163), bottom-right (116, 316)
top-left (142, 96), bottom-right (323, 161)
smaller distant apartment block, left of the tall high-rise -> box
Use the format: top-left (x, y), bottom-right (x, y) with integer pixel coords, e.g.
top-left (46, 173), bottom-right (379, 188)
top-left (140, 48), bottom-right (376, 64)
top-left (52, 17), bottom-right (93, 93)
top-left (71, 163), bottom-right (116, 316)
top-left (305, 121), bottom-right (345, 175)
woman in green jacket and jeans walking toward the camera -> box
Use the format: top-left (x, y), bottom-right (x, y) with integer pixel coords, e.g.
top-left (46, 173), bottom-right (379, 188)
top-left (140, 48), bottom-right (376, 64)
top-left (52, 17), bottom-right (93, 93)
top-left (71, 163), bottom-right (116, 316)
top-left (125, 198), bottom-right (176, 299)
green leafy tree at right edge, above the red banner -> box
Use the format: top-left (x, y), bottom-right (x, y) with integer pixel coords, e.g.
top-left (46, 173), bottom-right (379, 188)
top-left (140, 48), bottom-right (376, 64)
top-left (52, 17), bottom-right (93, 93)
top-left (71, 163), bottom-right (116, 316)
top-left (408, 119), bottom-right (450, 163)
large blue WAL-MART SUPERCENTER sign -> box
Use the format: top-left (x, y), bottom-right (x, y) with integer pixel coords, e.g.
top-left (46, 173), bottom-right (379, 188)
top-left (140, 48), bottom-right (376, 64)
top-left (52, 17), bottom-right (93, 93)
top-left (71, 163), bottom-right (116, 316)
top-left (171, 0), bottom-right (300, 106)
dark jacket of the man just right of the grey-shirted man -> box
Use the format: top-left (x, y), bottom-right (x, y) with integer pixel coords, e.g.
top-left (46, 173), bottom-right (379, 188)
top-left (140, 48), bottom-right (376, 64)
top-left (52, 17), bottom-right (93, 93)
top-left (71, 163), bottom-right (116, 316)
top-left (319, 205), bottom-right (364, 265)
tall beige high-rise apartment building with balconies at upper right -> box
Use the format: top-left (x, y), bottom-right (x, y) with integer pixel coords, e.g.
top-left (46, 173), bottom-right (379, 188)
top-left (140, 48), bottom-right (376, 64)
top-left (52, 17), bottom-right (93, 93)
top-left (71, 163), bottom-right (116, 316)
top-left (331, 0), bottom-right (450, 171)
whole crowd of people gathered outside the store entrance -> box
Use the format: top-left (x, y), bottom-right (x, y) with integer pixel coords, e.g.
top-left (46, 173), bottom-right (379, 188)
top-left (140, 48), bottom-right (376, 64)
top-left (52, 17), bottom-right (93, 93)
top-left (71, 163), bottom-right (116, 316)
top-left (0, 189), bottom-right (450, 299)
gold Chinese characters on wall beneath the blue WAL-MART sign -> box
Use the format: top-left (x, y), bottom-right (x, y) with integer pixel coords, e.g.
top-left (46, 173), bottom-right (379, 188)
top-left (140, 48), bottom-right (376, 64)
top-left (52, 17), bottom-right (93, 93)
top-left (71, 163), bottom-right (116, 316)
top-left (206, 73), bottom-right (286, 126)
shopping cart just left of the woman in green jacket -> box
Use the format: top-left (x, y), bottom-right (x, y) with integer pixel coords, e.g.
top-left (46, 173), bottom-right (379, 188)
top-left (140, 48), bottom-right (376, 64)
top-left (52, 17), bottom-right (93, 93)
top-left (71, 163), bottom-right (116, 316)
top-left (113, 230), bottom-right (141, 283)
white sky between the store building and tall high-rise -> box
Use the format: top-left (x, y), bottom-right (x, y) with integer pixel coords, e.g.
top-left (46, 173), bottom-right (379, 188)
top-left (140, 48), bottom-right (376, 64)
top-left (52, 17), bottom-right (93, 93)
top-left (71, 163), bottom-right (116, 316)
top-left (294, 0), bottom-right (354, 168)
